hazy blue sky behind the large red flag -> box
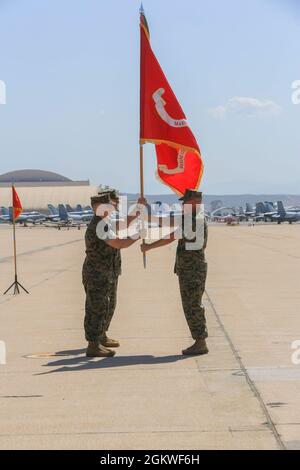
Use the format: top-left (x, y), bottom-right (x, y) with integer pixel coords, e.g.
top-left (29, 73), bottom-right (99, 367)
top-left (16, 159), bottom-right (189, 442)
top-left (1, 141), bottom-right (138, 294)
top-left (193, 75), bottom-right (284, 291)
top-left (0, 0), bottom-right (300, 194)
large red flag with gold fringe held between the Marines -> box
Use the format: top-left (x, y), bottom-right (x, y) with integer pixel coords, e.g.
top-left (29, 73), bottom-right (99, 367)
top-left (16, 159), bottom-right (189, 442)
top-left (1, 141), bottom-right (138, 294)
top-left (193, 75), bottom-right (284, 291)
top-left (140, 8), bottom-right (203, 195)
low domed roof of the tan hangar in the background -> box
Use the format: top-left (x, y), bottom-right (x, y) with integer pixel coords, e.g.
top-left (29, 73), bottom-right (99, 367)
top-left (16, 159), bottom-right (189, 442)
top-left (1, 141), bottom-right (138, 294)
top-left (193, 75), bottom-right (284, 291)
top-left (0, 170), bottom-right (71, 183)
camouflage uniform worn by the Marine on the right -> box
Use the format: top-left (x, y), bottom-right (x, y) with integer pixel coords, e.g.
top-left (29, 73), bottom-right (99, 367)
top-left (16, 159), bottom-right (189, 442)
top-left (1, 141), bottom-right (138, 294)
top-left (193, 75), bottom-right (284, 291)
top-left (175, 216), bottom-right (208, 341)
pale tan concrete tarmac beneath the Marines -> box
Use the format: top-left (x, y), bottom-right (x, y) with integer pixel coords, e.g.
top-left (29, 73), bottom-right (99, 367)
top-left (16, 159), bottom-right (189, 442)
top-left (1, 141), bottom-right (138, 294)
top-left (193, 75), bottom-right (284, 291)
top-left (0, 225), bottom-right (300, 450)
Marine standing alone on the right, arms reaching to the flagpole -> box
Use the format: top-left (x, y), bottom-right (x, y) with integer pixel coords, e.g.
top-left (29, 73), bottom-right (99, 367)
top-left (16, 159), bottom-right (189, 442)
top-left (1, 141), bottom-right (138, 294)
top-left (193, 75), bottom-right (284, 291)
top-left (141, 190), bottom-right (208, 355)
